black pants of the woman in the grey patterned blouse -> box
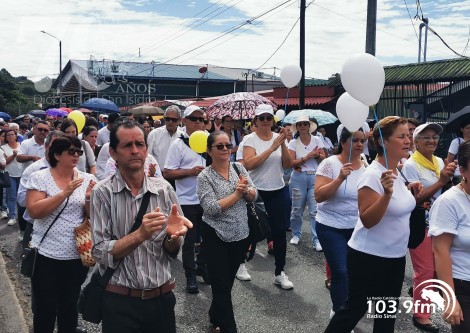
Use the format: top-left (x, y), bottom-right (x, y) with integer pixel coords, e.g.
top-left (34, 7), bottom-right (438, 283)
top-left (201, 223), bottom-right (247, 333)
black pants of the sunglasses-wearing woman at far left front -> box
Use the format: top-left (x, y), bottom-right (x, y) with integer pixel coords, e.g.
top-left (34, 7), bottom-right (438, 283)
top-left (31, 254), bottom-right (88, 333)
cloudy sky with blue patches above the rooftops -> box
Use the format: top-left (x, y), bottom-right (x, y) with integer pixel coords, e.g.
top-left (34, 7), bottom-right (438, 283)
top-left (0, 0), bottom-right (470, 81)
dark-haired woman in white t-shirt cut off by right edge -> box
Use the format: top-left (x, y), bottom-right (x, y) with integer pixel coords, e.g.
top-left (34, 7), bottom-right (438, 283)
top-left (429, 142), bottom-right (470, 333)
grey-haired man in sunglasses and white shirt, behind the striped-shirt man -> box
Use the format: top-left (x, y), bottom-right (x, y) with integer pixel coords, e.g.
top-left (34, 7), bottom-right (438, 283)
top-left (147, 105), bottom-right (182, 182)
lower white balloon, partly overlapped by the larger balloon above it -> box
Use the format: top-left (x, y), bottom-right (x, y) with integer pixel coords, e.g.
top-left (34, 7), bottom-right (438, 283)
top-left (336, 93), bottom-right (369, 132)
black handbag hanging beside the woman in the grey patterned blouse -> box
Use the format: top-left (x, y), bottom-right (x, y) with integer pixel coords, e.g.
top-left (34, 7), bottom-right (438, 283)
top-left (232, 163), bottom-right (271, 244)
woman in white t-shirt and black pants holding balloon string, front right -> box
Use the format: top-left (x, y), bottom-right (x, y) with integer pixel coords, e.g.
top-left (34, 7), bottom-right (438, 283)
top-left (325, 117), bottom-right (422, 333)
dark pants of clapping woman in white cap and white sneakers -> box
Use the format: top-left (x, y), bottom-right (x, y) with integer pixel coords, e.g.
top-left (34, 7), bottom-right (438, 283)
top-left (258, 188), bottom-right (287, 275)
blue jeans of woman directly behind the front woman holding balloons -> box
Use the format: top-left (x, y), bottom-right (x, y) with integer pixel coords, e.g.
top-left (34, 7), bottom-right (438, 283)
top-left (317, 223), bottom-right (354, 312)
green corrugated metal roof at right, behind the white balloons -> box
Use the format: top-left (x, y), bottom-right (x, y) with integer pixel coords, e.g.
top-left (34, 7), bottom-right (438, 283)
top-left (328, 58), bottom-right (470, 86)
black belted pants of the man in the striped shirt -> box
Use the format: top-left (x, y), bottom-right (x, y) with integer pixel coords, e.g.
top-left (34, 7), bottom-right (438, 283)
top-left (102, 291), bottom-right (176, 333)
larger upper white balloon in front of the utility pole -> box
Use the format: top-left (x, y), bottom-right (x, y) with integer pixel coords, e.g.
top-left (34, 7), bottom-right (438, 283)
top-left (341, 53), bottom-right (385, 106)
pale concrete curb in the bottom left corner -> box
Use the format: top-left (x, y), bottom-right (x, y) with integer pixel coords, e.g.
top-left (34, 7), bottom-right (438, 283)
top-left (0, 252), bottom-right (28, 333)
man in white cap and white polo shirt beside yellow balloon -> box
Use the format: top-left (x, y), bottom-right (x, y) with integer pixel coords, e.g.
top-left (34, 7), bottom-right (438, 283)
top-left (163, 105), bottom-right (207, 294)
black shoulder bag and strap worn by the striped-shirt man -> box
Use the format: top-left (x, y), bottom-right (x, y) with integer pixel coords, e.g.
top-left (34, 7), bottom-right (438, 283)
top-left (78, 192), bottom-right (151, 324)
